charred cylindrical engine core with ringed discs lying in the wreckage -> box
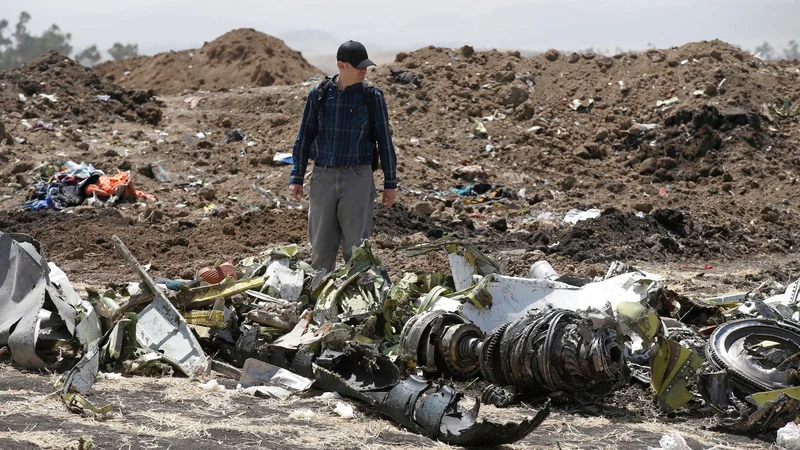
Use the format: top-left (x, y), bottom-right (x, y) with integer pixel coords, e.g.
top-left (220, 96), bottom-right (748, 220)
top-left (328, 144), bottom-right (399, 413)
top-left (400, 310), bottom-right (628, 405)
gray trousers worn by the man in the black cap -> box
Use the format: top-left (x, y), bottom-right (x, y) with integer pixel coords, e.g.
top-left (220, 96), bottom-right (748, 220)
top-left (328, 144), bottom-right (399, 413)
top-left (308, 165), bottom-right (377, 272)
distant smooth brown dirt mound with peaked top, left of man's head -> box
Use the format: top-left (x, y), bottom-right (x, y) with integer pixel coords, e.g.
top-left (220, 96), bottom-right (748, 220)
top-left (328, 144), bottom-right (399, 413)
top-left (94, 28), bottom-right (320, 94)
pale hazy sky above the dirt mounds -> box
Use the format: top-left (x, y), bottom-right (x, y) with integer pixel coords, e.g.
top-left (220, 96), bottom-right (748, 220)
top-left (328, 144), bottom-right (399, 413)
top-left (0, 0), bottom-right (800, 59)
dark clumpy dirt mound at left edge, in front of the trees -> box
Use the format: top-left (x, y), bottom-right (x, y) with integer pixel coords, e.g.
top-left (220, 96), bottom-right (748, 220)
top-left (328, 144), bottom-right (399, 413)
top-left (0, 51), bottom-right (161, 125)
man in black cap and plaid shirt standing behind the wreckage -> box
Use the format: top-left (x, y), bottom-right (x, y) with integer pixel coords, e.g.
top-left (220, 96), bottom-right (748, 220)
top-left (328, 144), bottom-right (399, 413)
top-left (289, 41), bottom-right (397, 272)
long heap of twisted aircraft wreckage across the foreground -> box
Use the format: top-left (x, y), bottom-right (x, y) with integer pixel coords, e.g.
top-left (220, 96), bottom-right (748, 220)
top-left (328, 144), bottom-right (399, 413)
top-left (7, 232), bottom-right (800, 446)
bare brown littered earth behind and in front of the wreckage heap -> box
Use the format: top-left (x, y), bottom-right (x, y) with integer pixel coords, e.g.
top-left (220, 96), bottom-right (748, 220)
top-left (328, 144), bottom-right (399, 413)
top-left (0, 37), bottom-right (800, 449)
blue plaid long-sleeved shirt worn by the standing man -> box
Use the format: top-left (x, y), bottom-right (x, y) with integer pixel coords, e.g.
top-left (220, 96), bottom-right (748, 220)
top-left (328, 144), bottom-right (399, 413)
top-left (289, 78), bottom-right (397, 189)
